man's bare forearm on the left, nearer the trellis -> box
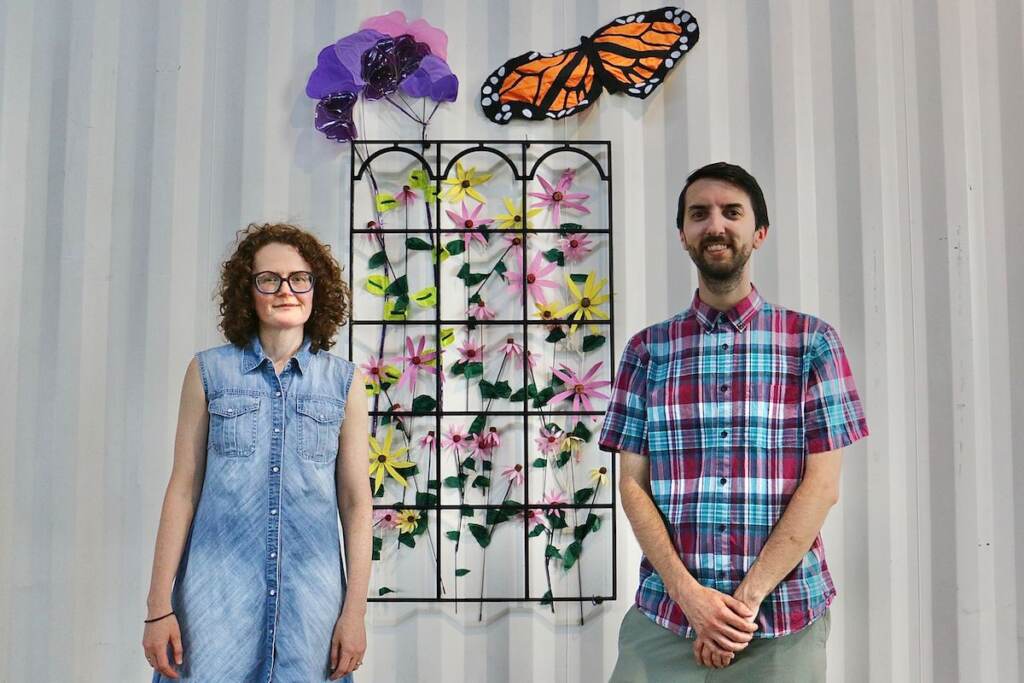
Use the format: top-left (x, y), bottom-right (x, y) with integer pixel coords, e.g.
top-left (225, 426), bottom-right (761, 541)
top-left (620, 479), bottom-right (697, 602)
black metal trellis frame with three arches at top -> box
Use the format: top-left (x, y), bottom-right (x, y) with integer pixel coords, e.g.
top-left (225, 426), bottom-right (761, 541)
top-left (348, 139), bottom-right (617, 604)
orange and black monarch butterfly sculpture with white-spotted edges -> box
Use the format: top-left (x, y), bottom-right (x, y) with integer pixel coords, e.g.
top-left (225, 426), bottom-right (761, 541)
top-left (480, 7), bottom-right (700, 125)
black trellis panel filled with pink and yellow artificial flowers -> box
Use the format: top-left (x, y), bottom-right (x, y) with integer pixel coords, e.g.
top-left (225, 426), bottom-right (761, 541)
top-left (349, 140), bottom-right (615, 622)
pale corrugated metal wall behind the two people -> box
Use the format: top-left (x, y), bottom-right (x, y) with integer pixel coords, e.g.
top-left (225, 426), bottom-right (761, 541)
top-left (0, 0), bottom-right (1024, 683)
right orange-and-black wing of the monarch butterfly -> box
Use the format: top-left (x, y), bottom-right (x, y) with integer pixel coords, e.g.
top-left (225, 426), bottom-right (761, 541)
top-left (588, 7), bottom-right (700, 99)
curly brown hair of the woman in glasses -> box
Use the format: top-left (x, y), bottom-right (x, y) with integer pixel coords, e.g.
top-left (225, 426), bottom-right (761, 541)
top-left (217, 223), bottom-right (352, 352)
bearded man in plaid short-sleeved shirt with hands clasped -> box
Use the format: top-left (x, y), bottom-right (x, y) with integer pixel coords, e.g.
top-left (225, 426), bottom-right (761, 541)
top-left (600, 163), bottom-right (867, 683)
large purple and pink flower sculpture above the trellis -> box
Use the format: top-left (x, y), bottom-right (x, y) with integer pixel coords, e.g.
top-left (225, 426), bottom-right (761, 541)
top-left (306, 11), bottom-right (459, 141)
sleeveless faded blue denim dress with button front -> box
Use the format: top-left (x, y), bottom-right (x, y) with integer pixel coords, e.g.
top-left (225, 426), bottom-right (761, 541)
top-left (153, 337), bottom-right (355, 683)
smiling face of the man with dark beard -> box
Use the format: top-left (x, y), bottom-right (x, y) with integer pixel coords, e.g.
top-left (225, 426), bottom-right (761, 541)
top-left (679, 178), bottom-right (768, 285)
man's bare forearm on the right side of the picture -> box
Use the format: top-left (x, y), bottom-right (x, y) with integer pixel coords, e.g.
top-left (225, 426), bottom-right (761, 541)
top-left (734, 480), bottom-right (836, 609)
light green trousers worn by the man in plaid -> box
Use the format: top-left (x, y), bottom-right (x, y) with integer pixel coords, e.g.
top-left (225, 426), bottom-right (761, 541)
top-left (610, 606), bottom-right (830, 683)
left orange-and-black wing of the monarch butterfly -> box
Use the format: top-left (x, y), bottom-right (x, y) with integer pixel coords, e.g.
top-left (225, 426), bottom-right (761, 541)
top-left (480, 47), bottom-right (601, 124)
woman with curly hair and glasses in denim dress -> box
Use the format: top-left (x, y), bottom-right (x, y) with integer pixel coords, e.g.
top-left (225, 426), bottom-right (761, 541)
top-left (142, 224), bottom-right (372, 683)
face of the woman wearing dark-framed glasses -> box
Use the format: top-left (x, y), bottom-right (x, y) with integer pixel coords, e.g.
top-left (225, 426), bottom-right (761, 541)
top-left (250, 242), bottom-right (313, 330)
